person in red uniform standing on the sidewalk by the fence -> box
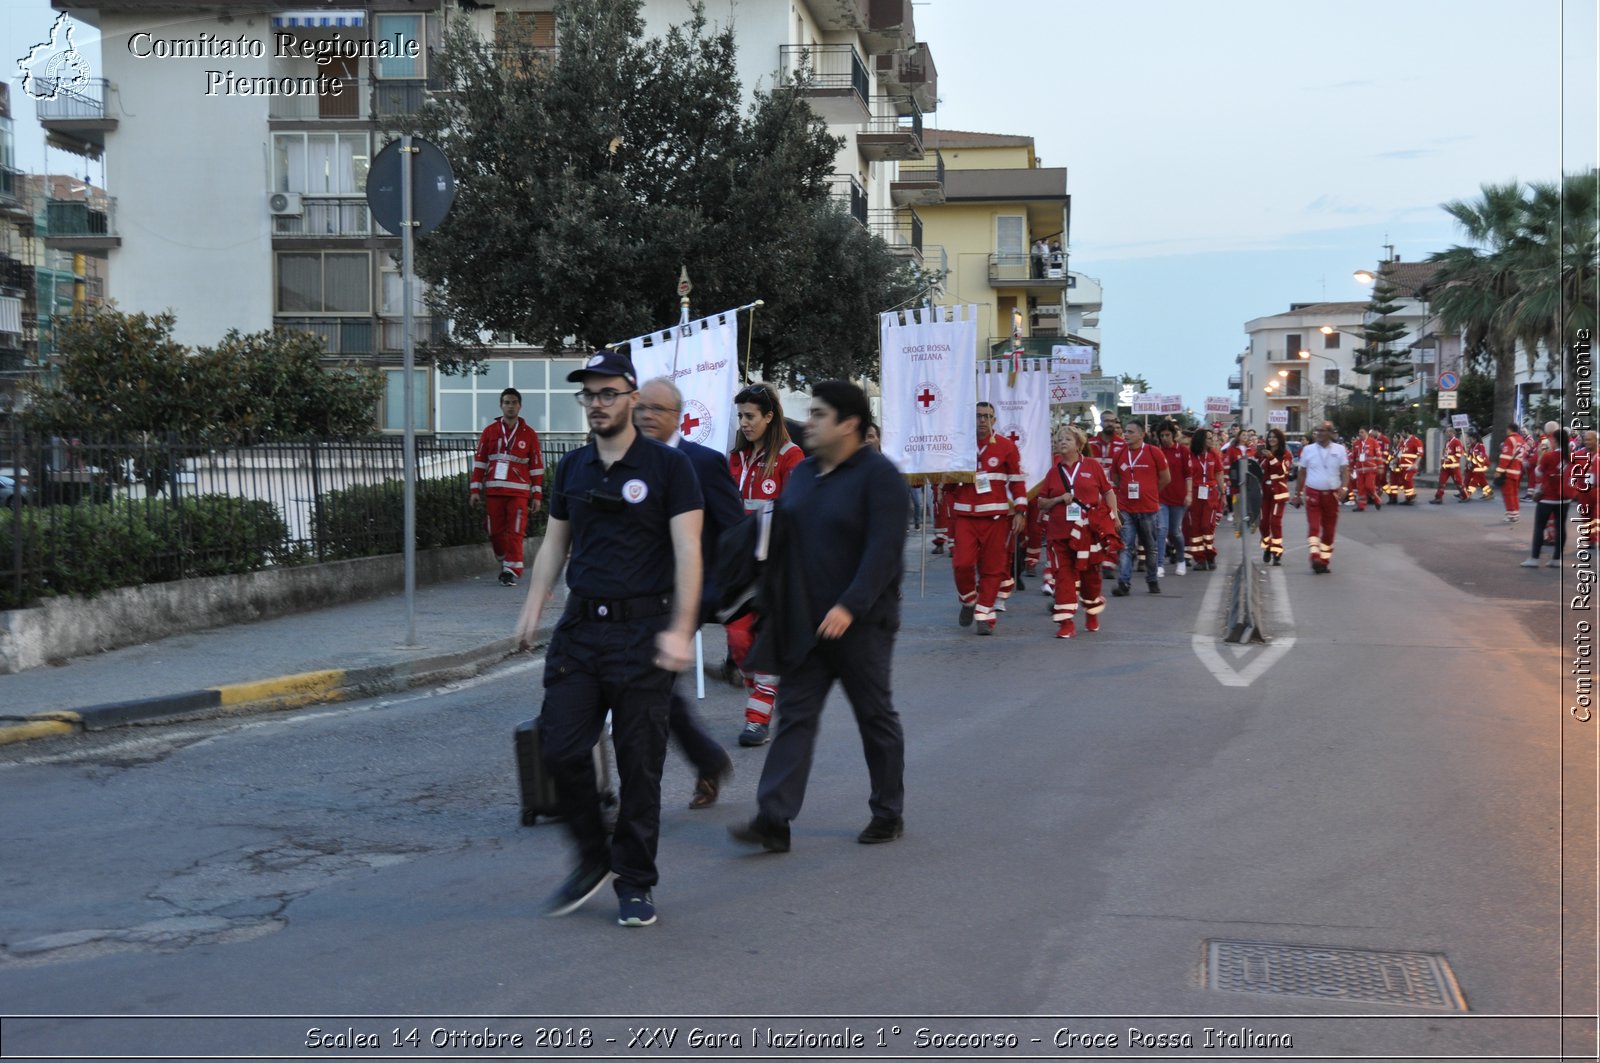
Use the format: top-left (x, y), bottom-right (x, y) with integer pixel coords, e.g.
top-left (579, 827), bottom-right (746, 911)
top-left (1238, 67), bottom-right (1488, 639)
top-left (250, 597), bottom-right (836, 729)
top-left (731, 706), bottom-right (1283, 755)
top-left (467, 387), bottom-right (544, 588)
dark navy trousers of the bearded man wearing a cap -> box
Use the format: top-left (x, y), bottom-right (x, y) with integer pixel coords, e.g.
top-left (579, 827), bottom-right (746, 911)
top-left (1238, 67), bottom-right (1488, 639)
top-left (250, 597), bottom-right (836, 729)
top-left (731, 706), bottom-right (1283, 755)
top-left (539, 612), bottom-right (672, 893)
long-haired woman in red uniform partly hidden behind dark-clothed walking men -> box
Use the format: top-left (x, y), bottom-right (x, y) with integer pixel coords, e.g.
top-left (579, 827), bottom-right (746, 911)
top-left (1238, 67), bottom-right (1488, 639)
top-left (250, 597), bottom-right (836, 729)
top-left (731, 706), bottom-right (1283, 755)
top-left (728, 384), bottom-right (805, 746)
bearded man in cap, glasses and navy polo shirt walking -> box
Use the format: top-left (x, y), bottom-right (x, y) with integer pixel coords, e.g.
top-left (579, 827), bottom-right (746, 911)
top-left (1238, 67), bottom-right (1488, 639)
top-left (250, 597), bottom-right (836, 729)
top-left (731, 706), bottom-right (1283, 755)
top-left (517, 351), bottom-right (702, 927)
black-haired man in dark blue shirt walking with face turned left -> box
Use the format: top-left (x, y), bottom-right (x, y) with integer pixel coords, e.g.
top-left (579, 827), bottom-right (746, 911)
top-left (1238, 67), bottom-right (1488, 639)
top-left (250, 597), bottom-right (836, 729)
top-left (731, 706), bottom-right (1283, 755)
top-left (730, 381), bottom-right (907, 853)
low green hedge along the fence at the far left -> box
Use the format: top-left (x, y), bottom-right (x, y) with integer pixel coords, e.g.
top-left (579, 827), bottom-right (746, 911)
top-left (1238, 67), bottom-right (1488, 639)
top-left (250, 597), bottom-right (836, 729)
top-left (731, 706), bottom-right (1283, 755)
top-left (0, 495), bottom-right (294, 608)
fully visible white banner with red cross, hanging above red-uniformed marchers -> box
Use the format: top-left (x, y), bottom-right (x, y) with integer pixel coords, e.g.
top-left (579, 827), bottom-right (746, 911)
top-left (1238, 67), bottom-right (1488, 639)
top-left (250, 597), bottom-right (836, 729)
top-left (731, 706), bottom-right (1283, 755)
top-left (878, 304), bottom-right (978, 480)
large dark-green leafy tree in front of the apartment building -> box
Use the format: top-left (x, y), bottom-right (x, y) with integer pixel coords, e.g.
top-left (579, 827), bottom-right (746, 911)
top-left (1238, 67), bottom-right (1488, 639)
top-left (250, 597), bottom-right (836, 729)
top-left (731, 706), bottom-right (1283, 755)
top-left (408, 0), bottom-right (922, 383)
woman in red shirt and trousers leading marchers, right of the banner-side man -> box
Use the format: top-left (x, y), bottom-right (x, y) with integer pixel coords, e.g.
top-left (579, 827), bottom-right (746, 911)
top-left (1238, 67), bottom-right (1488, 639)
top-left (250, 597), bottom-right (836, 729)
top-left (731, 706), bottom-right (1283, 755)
top-left (1038, 424), bottom-right (1122, 639)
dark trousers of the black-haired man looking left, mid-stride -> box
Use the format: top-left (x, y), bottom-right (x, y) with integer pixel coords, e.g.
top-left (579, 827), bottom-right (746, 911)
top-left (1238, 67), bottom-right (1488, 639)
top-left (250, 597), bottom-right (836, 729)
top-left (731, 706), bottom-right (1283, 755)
top-left (755, 620), bottom-right (906, 823)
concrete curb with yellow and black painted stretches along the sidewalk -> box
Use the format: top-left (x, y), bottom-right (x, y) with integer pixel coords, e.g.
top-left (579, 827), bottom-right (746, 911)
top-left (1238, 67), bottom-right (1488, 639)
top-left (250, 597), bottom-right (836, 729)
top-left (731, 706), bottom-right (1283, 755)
top-left (0, 639), bottom-right (524, 746)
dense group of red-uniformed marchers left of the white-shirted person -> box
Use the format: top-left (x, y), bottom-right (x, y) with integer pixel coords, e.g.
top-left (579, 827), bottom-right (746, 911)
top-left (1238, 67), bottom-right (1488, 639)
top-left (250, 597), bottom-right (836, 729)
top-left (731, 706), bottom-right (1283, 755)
top-left (933, 402), bottom-right (1294, 639)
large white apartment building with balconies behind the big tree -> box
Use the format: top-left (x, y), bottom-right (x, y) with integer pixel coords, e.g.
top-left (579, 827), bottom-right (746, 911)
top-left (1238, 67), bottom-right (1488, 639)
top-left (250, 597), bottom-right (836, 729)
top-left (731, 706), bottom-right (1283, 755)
top-left (40, 0), bottom-right (938, 432)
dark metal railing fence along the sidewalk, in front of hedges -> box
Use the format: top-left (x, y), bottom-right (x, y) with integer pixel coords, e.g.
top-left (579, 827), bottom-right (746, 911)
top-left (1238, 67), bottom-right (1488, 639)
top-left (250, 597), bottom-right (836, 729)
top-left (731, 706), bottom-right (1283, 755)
top-left (0, 429), bottom-right (582, 608)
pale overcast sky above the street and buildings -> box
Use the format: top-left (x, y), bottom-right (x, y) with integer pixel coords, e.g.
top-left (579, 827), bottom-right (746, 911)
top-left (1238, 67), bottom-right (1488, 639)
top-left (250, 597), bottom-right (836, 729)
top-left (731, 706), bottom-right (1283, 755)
top-left (0, 0), bottom-right (1600, 407)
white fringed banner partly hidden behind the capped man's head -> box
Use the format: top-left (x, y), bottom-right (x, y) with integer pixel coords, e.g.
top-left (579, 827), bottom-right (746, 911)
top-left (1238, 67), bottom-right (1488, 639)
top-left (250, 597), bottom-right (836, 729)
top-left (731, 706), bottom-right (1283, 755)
top-left (627, 311), bottom-right (739, 451)
